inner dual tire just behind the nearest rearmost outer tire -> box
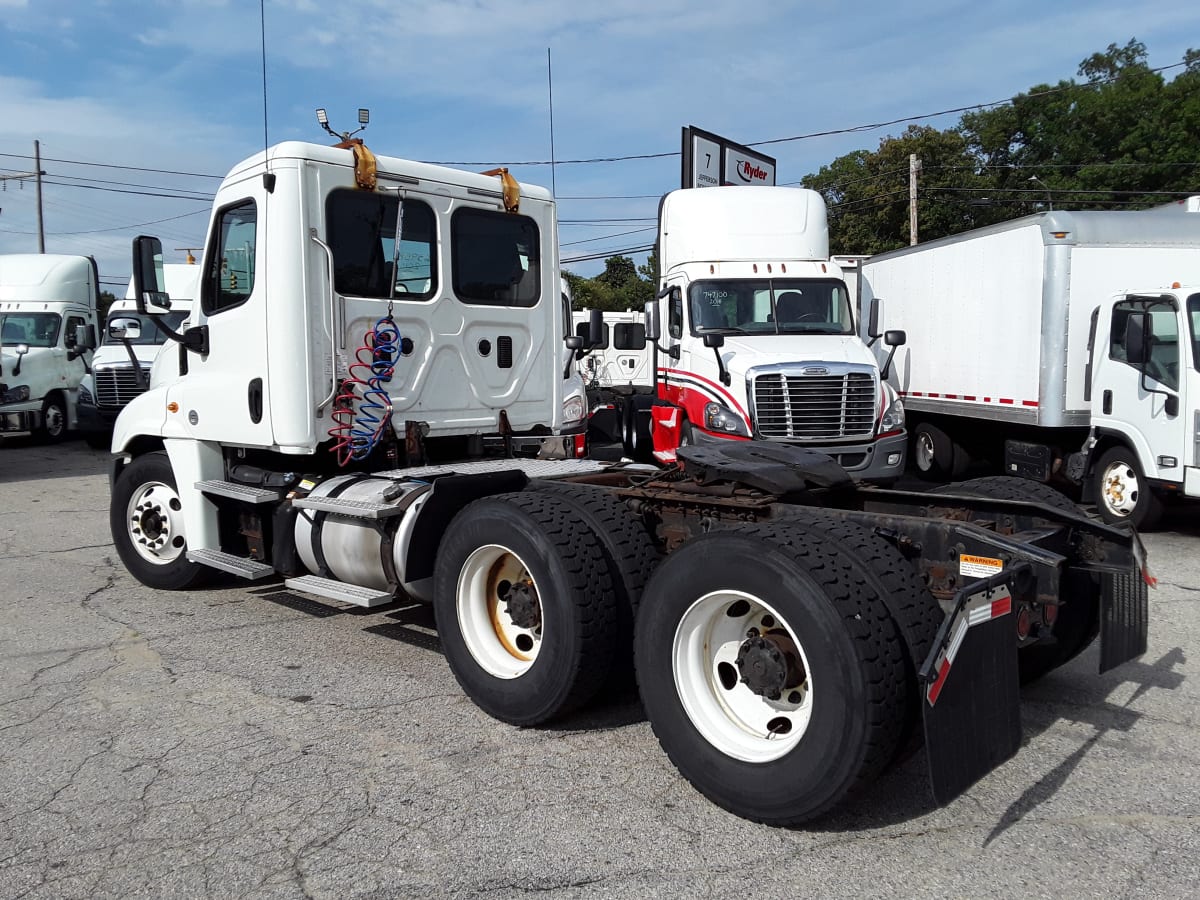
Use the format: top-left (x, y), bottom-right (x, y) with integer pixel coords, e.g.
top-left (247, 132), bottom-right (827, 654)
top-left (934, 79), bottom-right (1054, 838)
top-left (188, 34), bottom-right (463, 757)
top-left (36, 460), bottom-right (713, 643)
top-left (788, 510), bottom-right (946, 757)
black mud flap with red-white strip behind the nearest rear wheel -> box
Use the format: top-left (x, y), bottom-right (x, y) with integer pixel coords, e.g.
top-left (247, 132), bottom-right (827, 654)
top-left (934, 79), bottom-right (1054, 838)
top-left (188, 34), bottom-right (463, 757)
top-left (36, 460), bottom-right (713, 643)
top-left (920, 566), bottom-right (1027, 804)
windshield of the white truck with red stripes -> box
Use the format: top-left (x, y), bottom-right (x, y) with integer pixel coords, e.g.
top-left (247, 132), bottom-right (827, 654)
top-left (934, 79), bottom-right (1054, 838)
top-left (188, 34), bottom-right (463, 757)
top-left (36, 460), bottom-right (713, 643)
top-left (688, 278), bottom-right (854, 335)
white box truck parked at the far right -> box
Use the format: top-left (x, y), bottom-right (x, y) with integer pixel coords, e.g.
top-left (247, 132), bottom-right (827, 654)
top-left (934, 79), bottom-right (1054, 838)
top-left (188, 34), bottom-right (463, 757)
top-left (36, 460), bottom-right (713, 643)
top-left (862, 205), bottom-right (1200, 527)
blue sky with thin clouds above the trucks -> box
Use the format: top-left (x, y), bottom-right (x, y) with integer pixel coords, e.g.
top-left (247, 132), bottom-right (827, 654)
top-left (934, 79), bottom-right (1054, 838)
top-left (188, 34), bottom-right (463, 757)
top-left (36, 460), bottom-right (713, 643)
top-left (0, 0), bottom-right (1200, 288)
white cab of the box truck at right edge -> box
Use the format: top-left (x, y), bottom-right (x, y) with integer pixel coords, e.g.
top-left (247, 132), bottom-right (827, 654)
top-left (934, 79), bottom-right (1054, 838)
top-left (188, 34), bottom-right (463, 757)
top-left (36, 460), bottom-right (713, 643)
top-left (1086, 289), bottom-right (1200, 527)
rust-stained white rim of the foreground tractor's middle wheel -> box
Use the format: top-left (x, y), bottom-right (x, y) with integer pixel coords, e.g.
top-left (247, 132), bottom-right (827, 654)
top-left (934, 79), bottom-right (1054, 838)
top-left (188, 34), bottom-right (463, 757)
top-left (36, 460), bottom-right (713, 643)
top-left (455, 544), bottom-right (542, 678)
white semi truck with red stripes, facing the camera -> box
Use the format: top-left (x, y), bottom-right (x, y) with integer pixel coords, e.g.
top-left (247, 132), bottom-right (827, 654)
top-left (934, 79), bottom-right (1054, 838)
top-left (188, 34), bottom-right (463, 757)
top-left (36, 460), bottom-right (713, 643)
top-left (649, 187), bottom-right (907, 481)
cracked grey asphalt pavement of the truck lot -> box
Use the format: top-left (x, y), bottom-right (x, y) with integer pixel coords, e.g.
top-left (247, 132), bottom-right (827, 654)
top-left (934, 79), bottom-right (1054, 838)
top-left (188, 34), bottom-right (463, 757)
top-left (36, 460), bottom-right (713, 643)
top-left (0, 437), bottom-right (1200, 900)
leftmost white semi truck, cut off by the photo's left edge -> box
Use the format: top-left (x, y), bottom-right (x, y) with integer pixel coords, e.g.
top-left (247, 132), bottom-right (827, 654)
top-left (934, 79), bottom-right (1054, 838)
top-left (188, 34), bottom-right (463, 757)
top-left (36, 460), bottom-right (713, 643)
top-left (0, 253), bottom-right (100, 440)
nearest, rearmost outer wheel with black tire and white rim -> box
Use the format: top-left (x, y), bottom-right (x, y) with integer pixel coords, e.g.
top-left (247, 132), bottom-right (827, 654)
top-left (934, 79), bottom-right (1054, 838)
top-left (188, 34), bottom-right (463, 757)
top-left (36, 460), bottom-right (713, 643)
top-left (634, 523), bottom-right (906, 824)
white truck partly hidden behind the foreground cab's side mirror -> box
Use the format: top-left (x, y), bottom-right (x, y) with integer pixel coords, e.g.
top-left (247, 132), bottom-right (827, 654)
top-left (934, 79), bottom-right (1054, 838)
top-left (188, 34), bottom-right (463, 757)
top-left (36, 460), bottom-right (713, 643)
top-left (77, 263), bottom-right (200, 449)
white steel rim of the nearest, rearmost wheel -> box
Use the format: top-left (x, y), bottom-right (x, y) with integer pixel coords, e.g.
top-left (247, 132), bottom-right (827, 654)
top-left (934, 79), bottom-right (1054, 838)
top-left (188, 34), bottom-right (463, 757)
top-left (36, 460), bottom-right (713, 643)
top-left (671, 590), bottom-right (812, 763)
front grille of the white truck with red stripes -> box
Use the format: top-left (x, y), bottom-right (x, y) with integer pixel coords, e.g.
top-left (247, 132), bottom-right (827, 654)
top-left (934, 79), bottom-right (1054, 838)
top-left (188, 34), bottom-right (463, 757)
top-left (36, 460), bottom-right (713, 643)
top-left (754, 372), bottom-right (875, 442)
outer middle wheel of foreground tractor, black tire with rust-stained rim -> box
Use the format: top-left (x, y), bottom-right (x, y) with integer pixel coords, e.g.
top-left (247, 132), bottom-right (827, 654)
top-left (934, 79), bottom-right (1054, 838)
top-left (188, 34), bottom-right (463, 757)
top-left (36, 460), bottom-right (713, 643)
top-left (433, 491), bottom-right (617, 725)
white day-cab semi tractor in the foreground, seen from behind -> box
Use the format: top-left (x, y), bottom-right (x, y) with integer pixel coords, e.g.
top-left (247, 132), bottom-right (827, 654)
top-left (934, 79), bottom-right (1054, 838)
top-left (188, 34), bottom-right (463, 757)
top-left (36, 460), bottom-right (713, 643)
top-left (109, 135), bottom-right (1147, 823)
